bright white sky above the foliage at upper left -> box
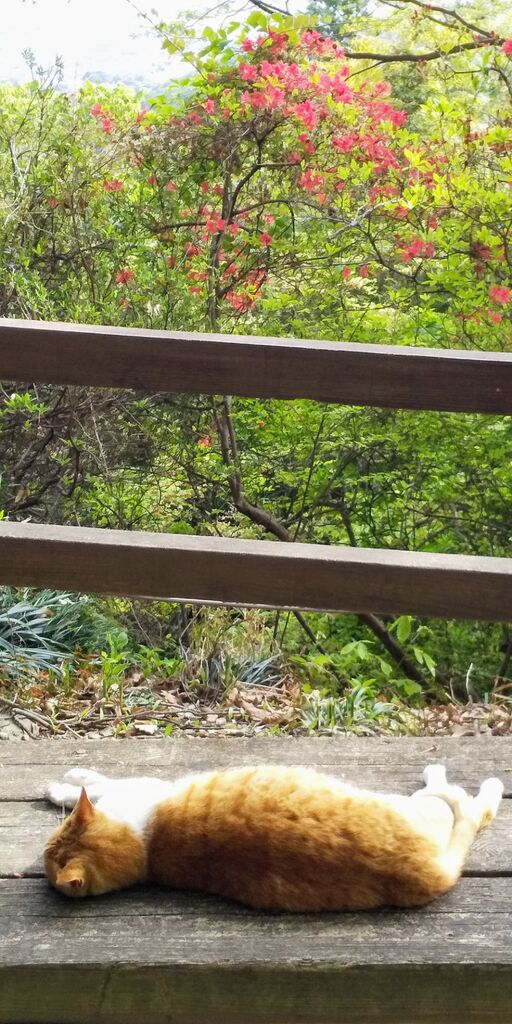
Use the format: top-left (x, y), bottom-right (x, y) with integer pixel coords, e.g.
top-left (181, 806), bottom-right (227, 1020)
top-left (0, 0), bottom-right (258, 89)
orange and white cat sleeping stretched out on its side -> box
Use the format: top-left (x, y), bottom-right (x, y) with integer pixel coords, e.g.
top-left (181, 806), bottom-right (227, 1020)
top-left (45, 765), bottom-right (503, 910)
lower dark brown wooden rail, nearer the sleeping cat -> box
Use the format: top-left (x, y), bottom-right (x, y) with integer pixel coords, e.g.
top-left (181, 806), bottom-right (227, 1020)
top-left (0, 523), bottom-right (512, 622)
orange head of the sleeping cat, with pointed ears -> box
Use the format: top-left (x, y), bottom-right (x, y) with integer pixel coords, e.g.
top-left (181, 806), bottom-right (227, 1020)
top-left (44, 790), bottom-right (145, 897)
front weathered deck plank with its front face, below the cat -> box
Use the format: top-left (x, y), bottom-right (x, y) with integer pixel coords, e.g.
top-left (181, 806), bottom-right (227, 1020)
top-left (0, 879), bottom-right (512, 1024)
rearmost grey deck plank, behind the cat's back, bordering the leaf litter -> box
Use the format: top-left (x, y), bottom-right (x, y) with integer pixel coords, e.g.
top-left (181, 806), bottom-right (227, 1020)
top-left (0, 736), bottom-right (512, 806)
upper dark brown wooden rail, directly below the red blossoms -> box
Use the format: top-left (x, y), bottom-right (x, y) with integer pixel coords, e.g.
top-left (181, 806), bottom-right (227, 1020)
top-left (0, 319), bottom-right (512, 414)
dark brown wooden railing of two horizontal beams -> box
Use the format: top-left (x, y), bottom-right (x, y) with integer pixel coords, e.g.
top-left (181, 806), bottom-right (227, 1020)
top-left (0, 319), bottom-right (512, 622)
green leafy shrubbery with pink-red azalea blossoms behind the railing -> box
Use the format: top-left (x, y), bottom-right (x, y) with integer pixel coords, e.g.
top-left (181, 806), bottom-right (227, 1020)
top-left (0, 4), bottom-right (512, 696)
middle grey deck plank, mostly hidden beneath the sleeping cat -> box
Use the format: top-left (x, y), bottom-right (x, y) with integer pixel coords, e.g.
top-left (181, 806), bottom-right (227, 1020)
top-left (0, 794), bottom-right (512, 878)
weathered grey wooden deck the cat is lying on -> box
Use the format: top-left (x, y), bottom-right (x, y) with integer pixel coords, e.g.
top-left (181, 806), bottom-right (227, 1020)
top-left (0, 737), bottom-right (512, 1024)
